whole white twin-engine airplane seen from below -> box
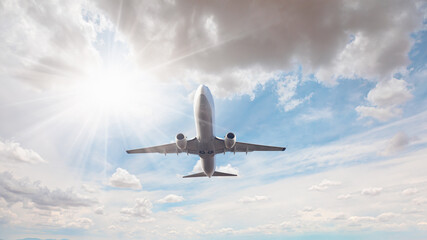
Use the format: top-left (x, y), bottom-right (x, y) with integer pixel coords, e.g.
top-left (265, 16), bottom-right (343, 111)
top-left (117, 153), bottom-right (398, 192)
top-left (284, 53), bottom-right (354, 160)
top-left (126, 85), bottom-right (286, 178)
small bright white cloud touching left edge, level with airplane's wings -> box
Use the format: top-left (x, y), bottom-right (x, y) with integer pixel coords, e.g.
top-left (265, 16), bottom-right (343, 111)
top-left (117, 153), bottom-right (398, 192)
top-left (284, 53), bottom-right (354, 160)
top-left (0, 141), bottom-right (47, 164)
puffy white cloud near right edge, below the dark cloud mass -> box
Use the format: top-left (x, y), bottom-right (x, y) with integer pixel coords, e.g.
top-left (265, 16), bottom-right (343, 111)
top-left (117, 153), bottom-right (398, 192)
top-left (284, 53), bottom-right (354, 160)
top-left (356, 78), bottom-right (413, 121)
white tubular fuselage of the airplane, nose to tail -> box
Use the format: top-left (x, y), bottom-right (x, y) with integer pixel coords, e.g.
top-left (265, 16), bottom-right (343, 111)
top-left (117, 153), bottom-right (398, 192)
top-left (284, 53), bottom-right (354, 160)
top-left (194, 85), bottom-right (215, 177)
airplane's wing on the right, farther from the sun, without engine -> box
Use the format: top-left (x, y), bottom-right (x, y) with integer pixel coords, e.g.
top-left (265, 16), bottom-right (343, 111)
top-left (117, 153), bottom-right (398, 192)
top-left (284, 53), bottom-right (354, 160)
top-left (215, 138), bottom-right (286, 153)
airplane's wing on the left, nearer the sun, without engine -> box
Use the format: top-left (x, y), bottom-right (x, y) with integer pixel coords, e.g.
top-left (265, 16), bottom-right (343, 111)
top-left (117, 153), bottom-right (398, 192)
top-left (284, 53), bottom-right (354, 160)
top-left (126, 138), bottom-right (198, 155)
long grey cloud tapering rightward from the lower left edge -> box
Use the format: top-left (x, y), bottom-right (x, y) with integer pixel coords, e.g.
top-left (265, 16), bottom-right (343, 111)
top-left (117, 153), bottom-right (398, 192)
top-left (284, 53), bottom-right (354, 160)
top-left (0, 172), bottom-right (96, 209)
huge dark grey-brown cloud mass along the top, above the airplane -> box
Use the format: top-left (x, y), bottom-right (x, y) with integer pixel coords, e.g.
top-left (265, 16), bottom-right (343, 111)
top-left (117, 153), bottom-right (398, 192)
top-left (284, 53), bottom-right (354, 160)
top-left (93, 0), bottom-right (422, 98)
